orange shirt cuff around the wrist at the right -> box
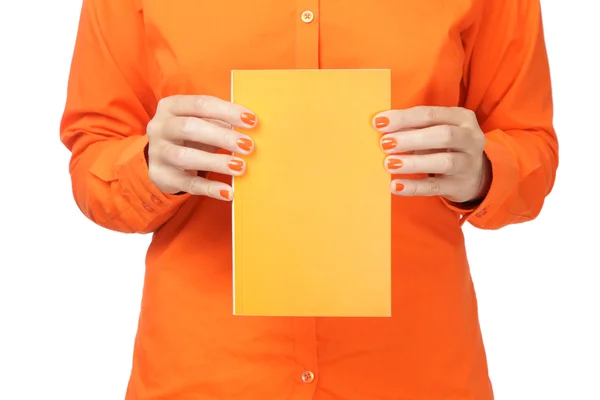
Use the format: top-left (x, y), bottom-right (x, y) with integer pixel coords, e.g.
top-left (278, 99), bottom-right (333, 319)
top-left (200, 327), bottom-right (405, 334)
top-left (440, 130), bottom-right (519, 228)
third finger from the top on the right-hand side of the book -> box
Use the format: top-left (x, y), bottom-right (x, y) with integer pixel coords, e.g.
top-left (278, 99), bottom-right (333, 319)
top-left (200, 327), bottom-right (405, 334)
top-left (385, 152), bottom-right (469, 175)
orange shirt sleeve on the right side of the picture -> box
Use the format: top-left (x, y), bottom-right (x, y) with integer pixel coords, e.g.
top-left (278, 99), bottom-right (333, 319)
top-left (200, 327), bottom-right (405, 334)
top-left (443, 0), bottom-right (558, 229)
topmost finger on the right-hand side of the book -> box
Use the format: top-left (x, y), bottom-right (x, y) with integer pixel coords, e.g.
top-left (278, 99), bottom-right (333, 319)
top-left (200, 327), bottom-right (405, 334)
top-left (373, 106), bottom-right (477, 132)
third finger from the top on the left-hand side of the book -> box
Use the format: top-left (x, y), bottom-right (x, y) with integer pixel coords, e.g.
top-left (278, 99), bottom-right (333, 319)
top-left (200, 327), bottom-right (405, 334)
top-left (161, 143), bottom-right (246, 176)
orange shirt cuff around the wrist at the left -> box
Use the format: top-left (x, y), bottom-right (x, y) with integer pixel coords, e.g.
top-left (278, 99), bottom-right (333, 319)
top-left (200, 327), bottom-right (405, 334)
top-left (116, 135), bottom-right (191, 230)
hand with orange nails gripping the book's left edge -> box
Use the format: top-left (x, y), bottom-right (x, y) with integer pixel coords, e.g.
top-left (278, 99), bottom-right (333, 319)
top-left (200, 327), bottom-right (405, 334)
top-left (147, 95), bottom-right (257, 200)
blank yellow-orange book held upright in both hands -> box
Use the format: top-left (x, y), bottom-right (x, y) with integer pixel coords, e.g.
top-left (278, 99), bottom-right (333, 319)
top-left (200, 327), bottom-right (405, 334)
top-left (231, 70), bottom-right (391, 317)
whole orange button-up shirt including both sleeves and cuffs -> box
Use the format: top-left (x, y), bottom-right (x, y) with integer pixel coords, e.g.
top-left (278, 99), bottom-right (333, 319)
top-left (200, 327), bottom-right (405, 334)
top-left (61, 0), bottom-right (558, 400)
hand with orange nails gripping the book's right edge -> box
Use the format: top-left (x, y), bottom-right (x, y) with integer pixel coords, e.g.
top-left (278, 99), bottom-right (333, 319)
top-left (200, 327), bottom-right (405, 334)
top-left (373, 106), bottom-right (491, 203)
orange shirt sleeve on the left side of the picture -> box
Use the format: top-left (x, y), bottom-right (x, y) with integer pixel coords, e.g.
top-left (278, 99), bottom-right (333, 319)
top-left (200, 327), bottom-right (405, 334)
top-left (60, 0), bottom-right (189, 233)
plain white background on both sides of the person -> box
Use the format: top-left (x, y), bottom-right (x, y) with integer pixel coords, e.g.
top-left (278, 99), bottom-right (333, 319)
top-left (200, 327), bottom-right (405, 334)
top-left (0, 0), bottom-right (600, 400)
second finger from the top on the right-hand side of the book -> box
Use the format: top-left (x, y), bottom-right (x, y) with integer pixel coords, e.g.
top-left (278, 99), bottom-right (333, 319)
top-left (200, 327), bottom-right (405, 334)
top-left (380, 125), bottom-right (472, 154)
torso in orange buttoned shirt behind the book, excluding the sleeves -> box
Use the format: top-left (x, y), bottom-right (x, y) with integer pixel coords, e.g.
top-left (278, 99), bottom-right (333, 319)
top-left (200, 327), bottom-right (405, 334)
top-left (127, 0), bottom-right (493, 400)
